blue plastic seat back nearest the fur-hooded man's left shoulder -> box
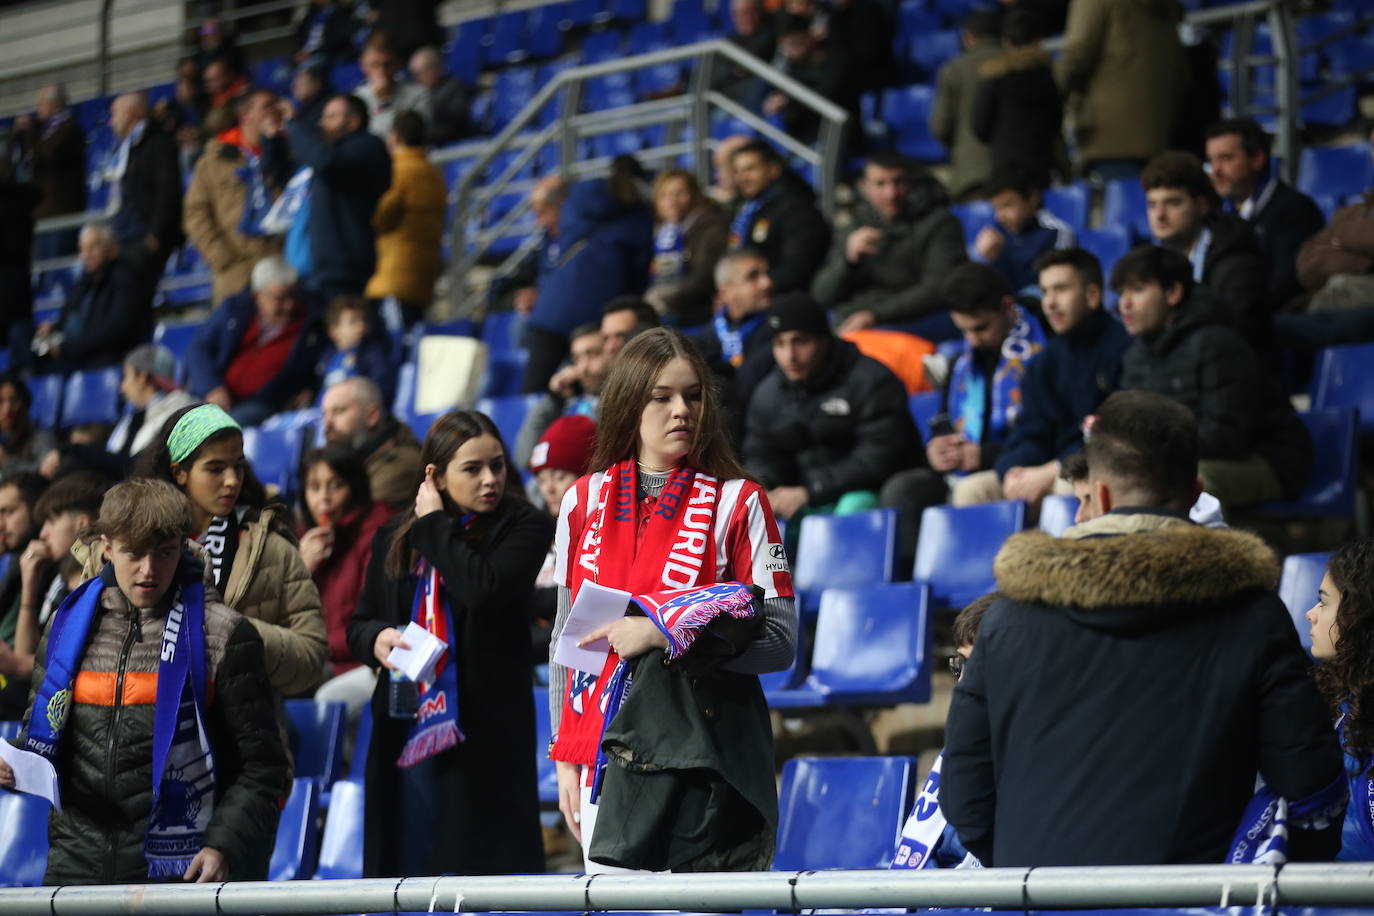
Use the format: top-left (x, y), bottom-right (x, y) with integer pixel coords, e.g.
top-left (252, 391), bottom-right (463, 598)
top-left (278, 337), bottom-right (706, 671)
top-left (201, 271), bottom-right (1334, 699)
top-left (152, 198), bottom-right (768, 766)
top-left (911, 500), bottom-right (1026, 608)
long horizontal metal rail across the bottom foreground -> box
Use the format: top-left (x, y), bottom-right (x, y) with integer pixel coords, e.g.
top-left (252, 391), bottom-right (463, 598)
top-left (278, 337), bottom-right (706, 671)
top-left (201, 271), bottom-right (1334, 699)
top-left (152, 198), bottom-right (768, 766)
top-left (0, 864), bottom-right (1374, 916)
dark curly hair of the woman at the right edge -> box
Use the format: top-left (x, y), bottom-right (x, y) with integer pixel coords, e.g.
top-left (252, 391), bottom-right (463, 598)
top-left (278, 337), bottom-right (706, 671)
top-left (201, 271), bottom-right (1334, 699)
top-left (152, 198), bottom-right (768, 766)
top-left (1314, 537), bottom-right (1374, 772)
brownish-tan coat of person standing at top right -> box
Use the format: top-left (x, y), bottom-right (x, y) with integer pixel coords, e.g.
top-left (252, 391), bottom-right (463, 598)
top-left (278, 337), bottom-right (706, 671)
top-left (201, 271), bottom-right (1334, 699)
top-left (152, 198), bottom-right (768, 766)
top-left (1055, 0), bottom-right (1189, 162)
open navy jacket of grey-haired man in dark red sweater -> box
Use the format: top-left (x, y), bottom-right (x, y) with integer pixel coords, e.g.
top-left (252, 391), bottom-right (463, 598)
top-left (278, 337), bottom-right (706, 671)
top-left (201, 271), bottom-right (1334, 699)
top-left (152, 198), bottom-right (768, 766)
top-left (185, 290), bottom-right (328, 409)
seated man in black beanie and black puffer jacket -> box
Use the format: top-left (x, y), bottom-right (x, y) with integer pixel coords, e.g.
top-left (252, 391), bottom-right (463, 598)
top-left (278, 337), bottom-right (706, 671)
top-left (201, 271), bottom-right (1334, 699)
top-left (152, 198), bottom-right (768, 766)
top-left (745, 293), bottom-right (922, 530)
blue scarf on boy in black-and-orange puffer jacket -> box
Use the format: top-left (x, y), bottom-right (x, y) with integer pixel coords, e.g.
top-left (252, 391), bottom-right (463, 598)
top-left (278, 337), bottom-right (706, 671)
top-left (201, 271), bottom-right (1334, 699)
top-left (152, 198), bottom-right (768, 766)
top-left (26, 568), bottom-right (214, 878)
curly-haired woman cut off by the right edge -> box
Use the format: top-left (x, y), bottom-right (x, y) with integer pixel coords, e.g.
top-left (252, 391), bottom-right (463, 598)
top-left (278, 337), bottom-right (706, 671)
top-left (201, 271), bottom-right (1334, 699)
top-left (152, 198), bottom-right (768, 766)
top-left (1307, 538), bottom-right (1374, 861)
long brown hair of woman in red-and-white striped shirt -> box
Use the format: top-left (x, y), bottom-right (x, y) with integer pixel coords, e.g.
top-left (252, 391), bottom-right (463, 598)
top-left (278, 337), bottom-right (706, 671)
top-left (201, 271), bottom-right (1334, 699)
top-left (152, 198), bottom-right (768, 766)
top-left (591, 328), bottom-right (747, 481)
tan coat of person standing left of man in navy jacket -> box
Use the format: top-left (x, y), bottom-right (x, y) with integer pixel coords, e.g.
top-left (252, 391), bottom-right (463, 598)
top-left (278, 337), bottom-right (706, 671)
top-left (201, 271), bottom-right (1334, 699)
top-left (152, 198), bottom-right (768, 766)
top-left (181, 140), bottom-right (282, 305)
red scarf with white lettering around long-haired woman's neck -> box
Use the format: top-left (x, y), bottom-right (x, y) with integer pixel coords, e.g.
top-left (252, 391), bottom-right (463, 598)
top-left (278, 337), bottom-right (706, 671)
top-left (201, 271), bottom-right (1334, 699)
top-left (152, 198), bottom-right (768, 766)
top-left (550, 459), bottom-right (720, 766)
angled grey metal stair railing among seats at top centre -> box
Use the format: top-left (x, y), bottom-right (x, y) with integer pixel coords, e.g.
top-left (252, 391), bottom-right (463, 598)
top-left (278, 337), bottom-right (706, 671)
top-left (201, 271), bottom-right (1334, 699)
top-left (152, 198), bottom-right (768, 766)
top-left (431, 38), bottom-right (848, 314)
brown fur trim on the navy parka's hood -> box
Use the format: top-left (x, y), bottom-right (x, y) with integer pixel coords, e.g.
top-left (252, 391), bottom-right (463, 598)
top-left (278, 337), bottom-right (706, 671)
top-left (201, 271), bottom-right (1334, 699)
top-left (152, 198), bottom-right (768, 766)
top-left (993, 526), bottom-right (1279, 608)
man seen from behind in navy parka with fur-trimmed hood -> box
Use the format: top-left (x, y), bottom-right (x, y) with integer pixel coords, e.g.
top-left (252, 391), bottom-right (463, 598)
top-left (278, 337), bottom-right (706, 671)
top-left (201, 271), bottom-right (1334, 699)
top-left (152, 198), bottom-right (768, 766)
top-left (940, 391), bottom-right (1347, 867)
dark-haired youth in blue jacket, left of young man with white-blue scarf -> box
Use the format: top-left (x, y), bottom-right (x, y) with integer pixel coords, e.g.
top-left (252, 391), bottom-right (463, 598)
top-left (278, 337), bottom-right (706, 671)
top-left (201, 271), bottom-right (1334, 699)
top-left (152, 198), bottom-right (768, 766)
top-left (973, 165), bottom-right (1077, 298)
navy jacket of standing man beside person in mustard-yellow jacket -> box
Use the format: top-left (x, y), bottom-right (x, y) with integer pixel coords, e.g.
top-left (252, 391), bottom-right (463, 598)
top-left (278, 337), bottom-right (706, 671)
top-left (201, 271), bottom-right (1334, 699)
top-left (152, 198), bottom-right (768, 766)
top-left (289, 121), bottom-right (392, 295)
